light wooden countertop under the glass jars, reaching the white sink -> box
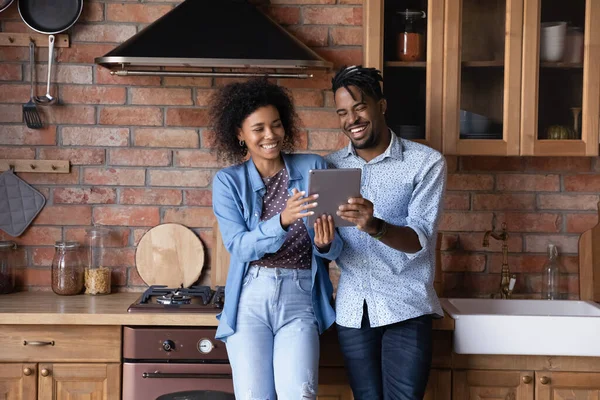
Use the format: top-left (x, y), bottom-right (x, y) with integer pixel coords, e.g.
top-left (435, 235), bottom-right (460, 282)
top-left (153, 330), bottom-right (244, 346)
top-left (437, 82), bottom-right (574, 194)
top-left (0, 292), bottom-right (454, 330)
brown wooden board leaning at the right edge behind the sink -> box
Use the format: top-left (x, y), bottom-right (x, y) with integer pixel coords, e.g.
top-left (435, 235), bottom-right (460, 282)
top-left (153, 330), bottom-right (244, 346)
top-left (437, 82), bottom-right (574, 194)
top-left (579, 203), bottom-right (600, 302)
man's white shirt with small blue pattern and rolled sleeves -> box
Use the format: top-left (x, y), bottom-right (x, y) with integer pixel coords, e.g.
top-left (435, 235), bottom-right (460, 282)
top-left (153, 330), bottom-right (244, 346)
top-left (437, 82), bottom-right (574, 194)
top-left (326, 131), bottom-right (446, 328)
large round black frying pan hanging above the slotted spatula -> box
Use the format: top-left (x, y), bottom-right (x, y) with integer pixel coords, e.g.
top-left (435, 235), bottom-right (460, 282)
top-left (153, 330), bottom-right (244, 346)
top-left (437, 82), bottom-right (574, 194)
top-left (18, 0), bottom-right (83, 35)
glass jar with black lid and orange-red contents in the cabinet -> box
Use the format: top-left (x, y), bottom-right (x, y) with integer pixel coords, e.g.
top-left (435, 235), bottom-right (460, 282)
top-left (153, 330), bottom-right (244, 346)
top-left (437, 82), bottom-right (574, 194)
top-left (396, 10), bottom-right (426, 61)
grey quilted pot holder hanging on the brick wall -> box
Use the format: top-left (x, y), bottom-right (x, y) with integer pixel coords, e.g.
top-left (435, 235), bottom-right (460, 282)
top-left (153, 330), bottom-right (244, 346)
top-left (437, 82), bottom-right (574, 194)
top-left (0, 170), bottom-right (46, 236)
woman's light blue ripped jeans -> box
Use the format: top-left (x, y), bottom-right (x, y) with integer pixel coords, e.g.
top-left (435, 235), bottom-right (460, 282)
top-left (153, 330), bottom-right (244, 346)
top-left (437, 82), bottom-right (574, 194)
top-left (226, 267), bottom-right (319, 400)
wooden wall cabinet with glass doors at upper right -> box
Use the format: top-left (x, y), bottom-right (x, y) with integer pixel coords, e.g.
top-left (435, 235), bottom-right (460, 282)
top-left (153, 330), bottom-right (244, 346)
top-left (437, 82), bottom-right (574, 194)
top-left (364, 0), bottom-right (600, 156)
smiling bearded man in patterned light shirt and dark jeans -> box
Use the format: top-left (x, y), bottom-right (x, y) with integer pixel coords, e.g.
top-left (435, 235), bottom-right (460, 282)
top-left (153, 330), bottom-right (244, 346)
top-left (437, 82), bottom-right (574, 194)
top-left (327, 66), bottom-right (446, 400)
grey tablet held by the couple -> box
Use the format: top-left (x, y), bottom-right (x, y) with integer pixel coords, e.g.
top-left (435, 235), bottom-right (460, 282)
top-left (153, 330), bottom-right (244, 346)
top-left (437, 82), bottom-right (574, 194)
top-left (308, 168), bottom-right (361, 227)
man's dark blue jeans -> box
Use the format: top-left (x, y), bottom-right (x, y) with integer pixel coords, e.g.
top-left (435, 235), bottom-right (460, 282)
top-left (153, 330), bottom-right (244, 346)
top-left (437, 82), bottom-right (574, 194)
top-left (337, 304), bottom-right (433, 400)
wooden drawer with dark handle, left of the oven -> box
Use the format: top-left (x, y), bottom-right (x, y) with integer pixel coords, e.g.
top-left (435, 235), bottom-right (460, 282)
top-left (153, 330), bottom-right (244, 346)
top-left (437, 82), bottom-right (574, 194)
top-left (0, 325), bottom-right (121, 362)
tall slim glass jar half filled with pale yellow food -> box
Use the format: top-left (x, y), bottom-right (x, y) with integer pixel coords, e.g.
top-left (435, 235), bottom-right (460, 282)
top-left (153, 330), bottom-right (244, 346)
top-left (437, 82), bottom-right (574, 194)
top-left (85, 228), bottom-right (110, 295)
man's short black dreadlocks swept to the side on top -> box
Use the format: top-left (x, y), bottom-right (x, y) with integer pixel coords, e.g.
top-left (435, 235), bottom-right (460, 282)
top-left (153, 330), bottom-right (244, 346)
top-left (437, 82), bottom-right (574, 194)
top-left (331, 65), bottom-right (383, 100)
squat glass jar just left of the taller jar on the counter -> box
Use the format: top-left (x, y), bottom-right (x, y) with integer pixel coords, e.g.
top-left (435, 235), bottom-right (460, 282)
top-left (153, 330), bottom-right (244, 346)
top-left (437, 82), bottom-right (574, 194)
top-left (52, 242), bottom-right (83, 296)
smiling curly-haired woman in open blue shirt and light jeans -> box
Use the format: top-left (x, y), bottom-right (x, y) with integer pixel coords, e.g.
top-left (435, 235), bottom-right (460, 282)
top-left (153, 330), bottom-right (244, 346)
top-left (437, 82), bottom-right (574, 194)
top-left (210, 78), bottom-right (342, 400)
